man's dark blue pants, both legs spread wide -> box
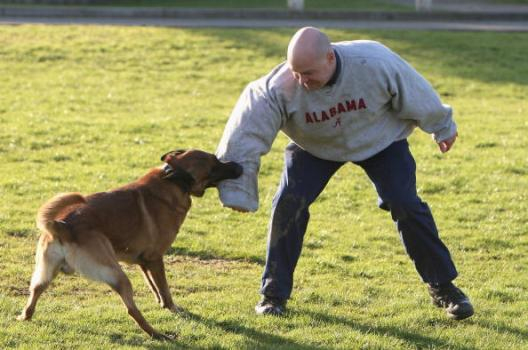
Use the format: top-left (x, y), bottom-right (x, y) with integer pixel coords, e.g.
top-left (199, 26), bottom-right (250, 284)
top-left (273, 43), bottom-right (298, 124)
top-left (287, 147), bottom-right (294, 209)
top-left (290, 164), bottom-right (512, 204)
top-left (260, 140), bottom-right (457, 299)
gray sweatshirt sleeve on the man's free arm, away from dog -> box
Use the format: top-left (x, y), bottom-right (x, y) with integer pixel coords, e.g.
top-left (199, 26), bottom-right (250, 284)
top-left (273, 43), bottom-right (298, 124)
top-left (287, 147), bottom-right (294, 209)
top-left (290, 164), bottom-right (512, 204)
top-left (389, 54), bottom-right (457, 142)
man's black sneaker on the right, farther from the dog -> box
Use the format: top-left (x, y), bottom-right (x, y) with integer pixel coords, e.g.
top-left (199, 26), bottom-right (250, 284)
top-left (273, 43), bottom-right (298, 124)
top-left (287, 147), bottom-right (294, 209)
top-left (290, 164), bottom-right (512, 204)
top-left (429, 283), bottom-right (474, 320)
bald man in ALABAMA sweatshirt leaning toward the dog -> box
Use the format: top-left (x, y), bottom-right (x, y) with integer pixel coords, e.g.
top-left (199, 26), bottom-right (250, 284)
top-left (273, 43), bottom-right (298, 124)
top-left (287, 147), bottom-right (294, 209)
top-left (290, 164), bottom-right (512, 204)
top-left (217, 27), bottom-right (473, 320)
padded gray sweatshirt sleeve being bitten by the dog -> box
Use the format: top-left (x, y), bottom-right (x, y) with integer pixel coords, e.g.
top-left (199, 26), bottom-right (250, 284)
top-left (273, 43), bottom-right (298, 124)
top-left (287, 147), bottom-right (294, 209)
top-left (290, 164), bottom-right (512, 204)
top-left (216, 81), bottom-right (282, 212)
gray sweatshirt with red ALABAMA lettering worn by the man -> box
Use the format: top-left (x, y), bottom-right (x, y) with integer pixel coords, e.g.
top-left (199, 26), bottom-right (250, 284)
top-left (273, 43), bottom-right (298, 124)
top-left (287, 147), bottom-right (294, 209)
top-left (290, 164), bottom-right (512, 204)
top-left (216, 40), bottom-right (456, 211)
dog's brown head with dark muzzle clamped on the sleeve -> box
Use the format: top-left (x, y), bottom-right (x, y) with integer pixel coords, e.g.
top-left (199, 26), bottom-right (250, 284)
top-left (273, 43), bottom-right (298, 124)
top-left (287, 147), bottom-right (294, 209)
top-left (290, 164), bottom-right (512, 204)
top-left (161, 149), bottom-right (242, 197)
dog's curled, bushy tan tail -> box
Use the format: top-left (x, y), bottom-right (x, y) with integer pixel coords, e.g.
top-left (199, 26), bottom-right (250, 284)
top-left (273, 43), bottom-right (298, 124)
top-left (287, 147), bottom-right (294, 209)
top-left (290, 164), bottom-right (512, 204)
top-left (37, 193), bottom-right (86, 241)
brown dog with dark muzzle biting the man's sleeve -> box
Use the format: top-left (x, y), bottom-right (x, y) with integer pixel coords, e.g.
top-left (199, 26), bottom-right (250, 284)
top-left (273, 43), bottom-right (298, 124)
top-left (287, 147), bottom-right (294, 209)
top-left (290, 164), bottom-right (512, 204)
top-left (18, 150), bottom-right (242, 339)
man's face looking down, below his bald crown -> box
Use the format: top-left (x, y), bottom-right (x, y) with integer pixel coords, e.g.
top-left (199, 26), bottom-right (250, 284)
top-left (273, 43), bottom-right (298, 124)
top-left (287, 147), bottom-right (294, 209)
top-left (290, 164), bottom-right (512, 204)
top-left (288, 55), bottom-right (334, 90)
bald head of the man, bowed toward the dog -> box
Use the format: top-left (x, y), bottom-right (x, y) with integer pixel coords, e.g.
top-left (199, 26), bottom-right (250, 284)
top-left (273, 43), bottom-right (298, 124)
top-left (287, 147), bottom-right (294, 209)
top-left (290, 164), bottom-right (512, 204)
top-left (287, 27), bottom-right (335, 90)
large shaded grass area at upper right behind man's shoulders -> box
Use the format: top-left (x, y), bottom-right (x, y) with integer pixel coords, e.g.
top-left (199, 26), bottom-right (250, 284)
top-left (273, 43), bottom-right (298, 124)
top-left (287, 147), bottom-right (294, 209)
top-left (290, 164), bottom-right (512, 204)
top-left (192, 28), bottom-right (528, 85)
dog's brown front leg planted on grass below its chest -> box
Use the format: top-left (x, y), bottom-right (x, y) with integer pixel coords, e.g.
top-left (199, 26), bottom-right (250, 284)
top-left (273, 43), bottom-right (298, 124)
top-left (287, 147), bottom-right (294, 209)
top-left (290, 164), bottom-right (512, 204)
top-left (140, 257), bottom-right (183, 313)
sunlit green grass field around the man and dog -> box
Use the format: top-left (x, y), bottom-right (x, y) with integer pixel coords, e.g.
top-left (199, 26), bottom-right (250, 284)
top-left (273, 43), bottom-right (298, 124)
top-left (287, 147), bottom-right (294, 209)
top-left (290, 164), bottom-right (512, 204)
top-left (0, 25), bottom-right (528, 350)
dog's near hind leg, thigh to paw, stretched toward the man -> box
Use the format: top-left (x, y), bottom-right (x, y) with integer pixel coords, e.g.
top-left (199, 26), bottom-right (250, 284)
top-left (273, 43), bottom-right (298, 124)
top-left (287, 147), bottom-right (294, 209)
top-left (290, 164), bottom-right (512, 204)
top-left (66, 232), bottom-right (172, 339)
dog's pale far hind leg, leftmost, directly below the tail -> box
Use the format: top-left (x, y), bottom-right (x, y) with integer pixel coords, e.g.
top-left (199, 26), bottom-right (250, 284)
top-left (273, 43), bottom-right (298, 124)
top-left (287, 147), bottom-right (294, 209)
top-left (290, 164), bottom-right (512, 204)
top-left (17, 234), bottom-right (64, 321)
